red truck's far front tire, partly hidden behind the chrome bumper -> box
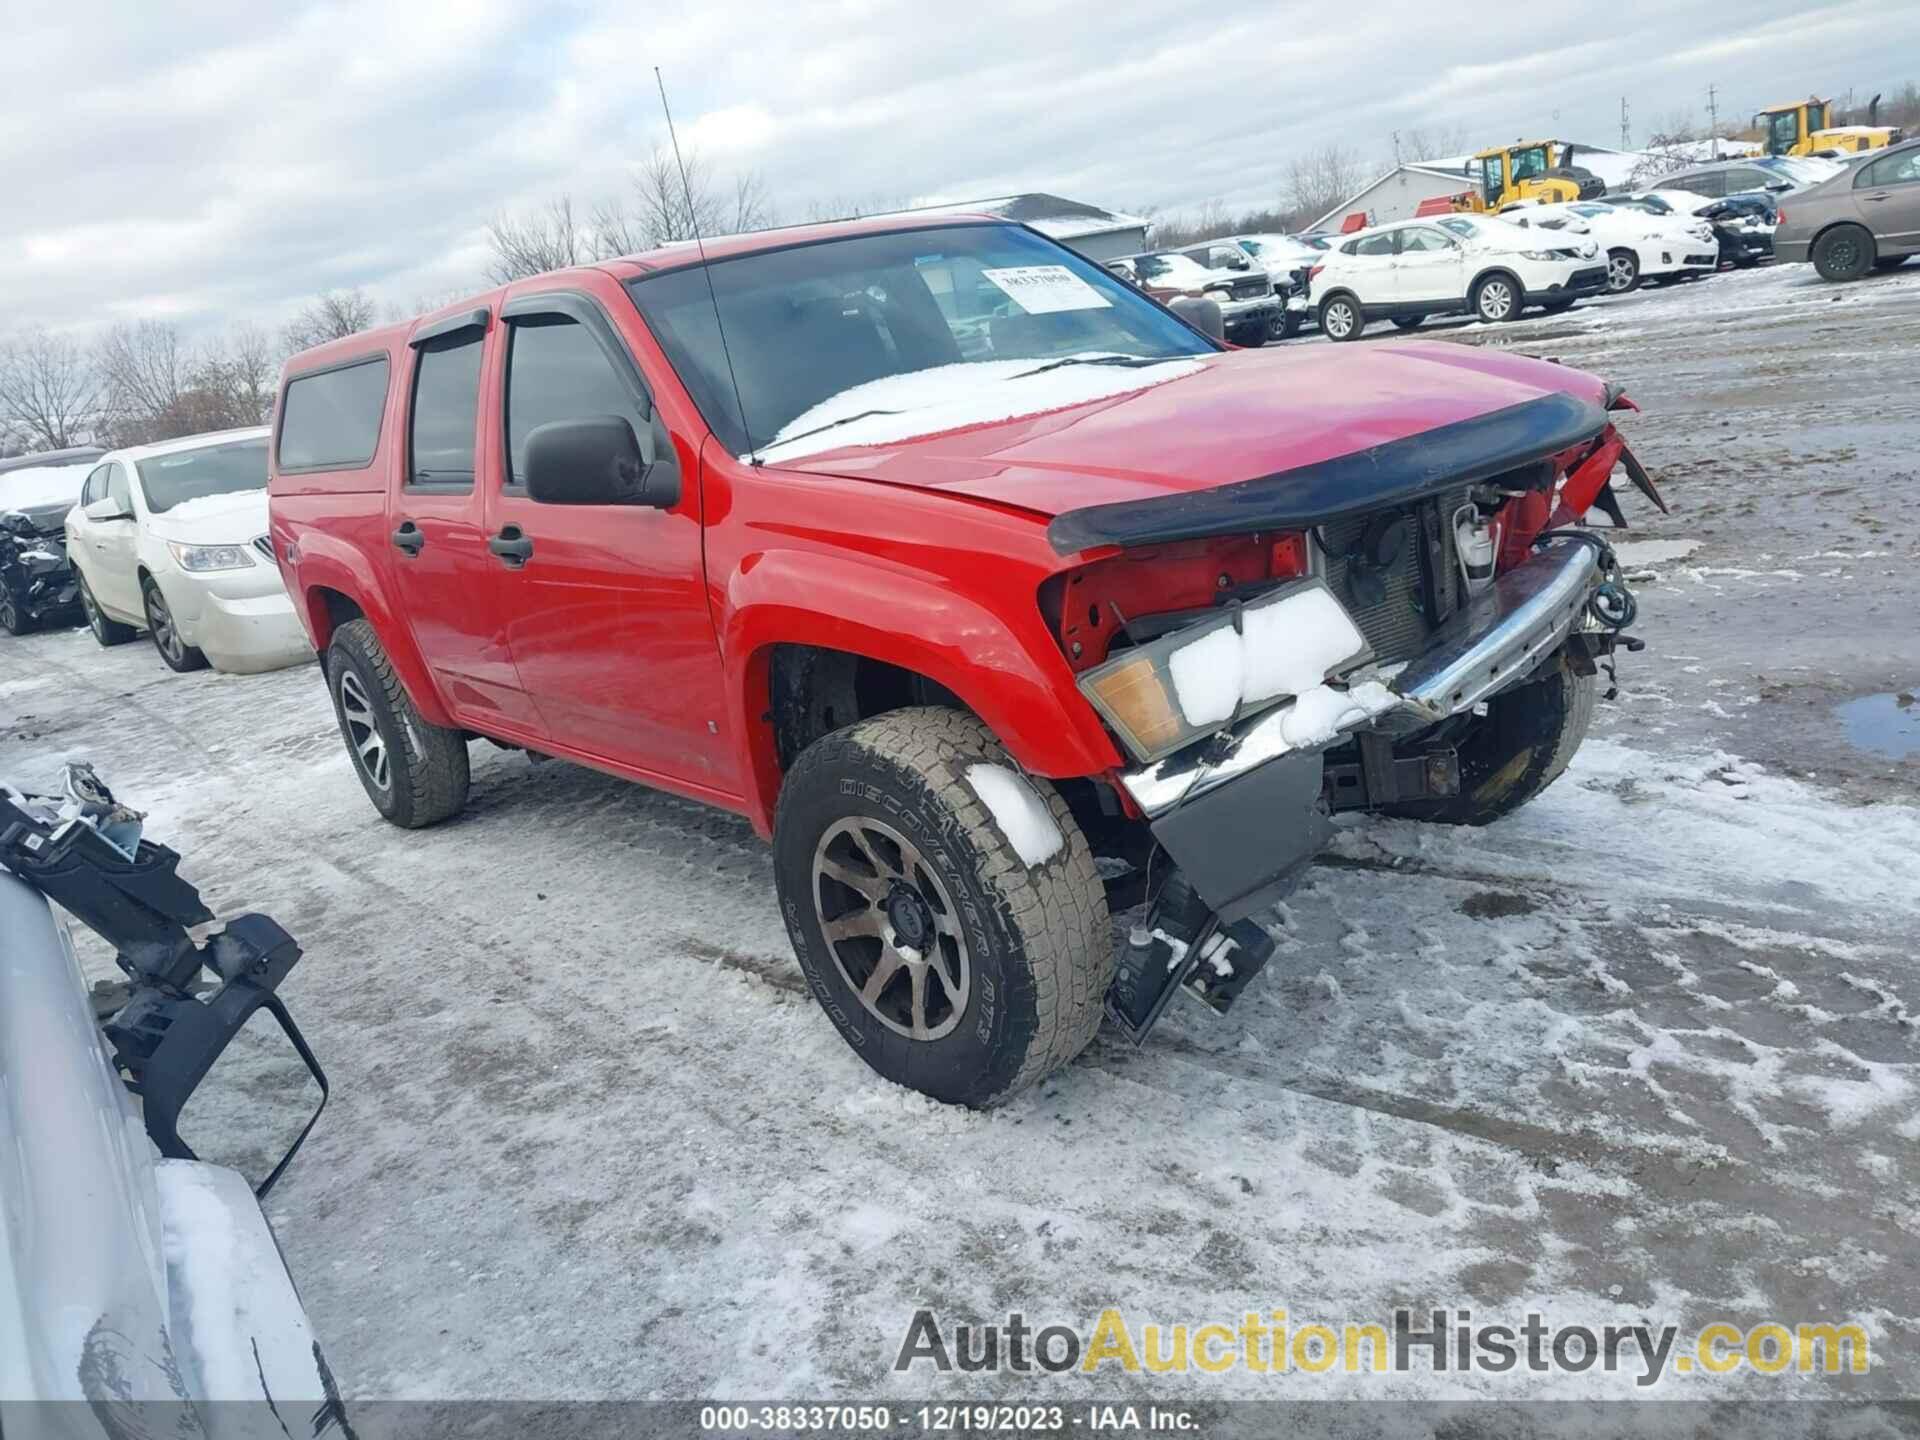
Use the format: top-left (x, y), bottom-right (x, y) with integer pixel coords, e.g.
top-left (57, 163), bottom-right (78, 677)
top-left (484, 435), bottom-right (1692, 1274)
top-left (1380, 660), bottom-right (1596, 826)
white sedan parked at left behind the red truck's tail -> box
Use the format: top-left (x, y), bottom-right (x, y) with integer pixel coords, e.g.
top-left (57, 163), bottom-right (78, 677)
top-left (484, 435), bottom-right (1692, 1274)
top-left (67, 426), bottom-right (313, 674)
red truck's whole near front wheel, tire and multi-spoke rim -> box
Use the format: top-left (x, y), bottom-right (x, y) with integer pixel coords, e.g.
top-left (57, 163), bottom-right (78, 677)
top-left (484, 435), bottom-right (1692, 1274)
top-left (774, 707), bottom-right (1114, 1106)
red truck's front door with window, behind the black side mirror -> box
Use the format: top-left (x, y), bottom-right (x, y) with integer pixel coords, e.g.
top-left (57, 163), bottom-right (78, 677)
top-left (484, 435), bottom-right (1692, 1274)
top-left (488, 280), bottom-right (741, 795)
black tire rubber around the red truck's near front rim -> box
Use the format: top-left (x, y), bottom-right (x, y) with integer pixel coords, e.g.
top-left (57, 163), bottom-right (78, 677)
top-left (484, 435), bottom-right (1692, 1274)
top-left (774, 707), bottom-right (1114, 1106)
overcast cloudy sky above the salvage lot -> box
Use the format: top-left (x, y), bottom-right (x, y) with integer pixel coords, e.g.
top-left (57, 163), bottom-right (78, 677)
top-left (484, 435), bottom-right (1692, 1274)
top-left (0, 0), bottom-right (1920, 332)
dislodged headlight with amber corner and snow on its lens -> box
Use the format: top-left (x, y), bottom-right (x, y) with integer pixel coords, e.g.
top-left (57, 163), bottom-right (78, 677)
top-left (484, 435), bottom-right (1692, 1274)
top-left (1079, 580), bottom-right (1373, 764)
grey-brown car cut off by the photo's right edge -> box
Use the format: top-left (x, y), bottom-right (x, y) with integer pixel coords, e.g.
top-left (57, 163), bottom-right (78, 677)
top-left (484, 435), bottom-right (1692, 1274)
top-left (1774, 138), bottom-right (1920, 280)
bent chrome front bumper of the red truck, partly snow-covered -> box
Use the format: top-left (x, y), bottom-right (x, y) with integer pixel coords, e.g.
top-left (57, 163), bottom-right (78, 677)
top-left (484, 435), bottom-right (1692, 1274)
top-left (1119, 541), bottom-right (1599, 818)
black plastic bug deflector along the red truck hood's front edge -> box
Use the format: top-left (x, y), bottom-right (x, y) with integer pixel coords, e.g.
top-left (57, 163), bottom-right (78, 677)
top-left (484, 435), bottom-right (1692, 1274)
top-left (1046, 392), bottom-right (1607, 555)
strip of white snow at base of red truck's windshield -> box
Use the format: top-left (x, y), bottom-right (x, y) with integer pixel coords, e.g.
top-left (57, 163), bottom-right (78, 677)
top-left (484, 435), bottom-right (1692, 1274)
top-left (741, 351), bottom-right (1202, 465)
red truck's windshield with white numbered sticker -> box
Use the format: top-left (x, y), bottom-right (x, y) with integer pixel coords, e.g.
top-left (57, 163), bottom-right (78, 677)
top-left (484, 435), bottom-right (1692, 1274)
top-left (628, 225), bottom-right (1213, 455)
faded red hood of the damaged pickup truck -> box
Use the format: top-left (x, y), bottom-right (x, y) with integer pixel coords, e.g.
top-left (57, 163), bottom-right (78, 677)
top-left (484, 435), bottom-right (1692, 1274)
top-left (768, 340), bottom-right (1609, 545)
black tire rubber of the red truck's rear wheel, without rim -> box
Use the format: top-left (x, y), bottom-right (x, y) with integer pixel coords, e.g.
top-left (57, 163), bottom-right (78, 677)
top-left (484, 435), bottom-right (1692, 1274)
top-left (326, 620), bottom-right (468, 829)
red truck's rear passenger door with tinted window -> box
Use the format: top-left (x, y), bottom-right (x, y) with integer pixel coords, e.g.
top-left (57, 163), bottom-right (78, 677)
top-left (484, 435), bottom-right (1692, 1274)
top-left (388, 318), bottom-right (545, 739)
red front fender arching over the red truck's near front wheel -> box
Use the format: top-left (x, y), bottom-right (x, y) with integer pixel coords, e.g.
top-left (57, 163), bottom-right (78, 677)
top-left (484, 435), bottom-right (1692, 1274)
top-left (716, 549), bottom-right (1121, 833)
